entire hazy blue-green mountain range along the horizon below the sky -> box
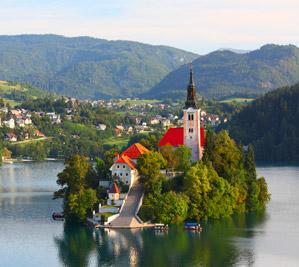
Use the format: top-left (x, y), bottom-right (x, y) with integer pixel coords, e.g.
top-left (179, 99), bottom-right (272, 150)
top-left (0, 35), bottom-right (299, 99)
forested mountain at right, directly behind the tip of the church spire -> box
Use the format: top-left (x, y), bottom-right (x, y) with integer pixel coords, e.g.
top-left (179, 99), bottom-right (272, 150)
top-left (144, 45), bottom-right (299, 99)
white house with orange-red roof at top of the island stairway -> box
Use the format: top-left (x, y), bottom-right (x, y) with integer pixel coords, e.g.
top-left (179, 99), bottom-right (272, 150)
top-left (110, 143), bottom-right (150, 187)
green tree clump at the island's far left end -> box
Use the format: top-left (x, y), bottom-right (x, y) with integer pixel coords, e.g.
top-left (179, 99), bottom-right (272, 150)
top-left (54, 155), bottom-right (97, 222)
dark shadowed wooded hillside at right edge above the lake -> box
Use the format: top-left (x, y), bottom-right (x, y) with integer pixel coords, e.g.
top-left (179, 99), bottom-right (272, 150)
top-left (227, 83), bottom-right (299, 163)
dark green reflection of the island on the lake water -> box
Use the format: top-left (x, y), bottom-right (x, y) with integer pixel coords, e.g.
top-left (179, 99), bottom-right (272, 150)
top-left (55, 213), bottom-right (265, 267)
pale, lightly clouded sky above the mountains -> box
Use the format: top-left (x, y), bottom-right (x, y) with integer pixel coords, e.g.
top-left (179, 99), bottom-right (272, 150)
top-left (0, 0), bottom-right (299, 54)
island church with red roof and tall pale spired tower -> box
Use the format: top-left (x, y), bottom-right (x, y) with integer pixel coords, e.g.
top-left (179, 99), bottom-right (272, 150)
top-left (158, 66), bottom-right (205, 161)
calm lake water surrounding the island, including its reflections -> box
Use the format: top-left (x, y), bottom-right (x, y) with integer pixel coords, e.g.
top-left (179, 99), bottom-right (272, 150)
top-left (0, 162), bottom-right (299, 267)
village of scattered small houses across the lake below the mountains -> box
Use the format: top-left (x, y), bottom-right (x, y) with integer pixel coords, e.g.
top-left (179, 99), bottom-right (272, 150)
top-left (0, 97), bottom-right (227, 147)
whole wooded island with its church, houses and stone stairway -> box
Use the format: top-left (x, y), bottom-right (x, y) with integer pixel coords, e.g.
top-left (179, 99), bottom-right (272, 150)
top-left (54, 68), bottom-right (270, 228)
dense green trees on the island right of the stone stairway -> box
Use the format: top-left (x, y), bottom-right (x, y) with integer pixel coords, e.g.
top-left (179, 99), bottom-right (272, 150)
top-left (138, 131), bottom-right (270, 224)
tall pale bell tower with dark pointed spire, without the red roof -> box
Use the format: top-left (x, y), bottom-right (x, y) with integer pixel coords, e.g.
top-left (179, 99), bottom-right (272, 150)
top-left (184, 64), bottom-right (203, 161)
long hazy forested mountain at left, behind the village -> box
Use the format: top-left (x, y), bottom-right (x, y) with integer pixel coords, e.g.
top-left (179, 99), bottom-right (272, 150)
top-left (0, 35), bottom-right (197, 98)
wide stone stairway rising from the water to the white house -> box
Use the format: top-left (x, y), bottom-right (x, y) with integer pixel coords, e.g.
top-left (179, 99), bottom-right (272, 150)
top-left (106, 183), bottom-right (153, 228)
